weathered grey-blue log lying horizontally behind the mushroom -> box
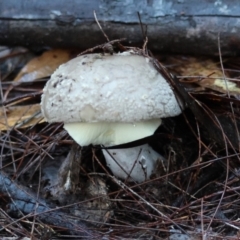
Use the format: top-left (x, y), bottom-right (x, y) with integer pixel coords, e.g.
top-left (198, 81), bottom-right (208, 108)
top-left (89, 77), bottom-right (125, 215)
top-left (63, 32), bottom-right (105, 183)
top-left (0, 0), bottom-right (240, 55)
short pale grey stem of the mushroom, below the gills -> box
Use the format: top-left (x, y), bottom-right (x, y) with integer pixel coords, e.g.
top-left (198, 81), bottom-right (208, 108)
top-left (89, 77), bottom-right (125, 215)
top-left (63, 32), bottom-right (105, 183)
top-left (102, 144), bottom-right (163, 182)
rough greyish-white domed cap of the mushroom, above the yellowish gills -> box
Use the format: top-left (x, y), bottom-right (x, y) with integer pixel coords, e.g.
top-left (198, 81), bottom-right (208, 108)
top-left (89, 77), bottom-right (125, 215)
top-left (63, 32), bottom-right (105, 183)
top-left (41, 52), bottom-right (181, 123)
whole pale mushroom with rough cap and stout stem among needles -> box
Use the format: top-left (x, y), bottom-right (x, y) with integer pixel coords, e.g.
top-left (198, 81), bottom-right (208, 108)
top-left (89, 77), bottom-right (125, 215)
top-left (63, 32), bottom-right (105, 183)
top-left (41, 51), bottom-right (181, 182)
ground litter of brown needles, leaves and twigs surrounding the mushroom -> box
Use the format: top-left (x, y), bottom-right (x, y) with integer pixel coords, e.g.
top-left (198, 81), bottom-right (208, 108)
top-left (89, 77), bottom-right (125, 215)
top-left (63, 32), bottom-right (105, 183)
top-left (0, 30), bottom-right (240, 239)
